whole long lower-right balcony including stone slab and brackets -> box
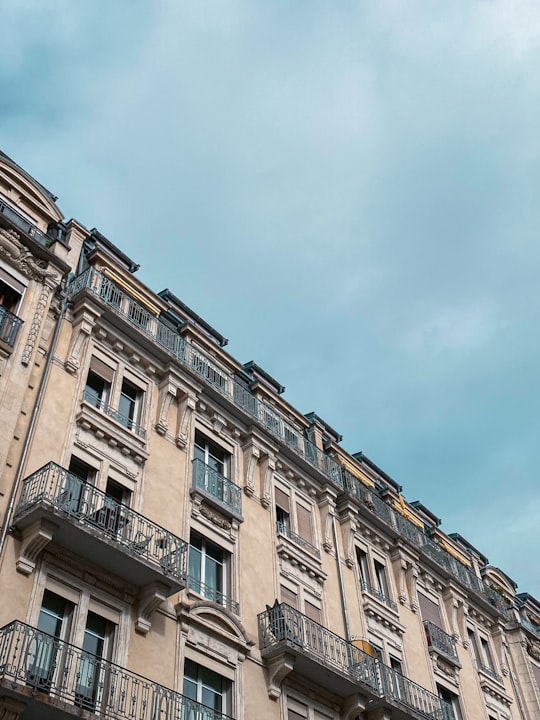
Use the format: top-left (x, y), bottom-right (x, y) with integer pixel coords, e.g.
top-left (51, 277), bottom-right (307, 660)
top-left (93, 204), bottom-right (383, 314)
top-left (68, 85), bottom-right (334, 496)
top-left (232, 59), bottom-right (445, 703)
top-left (258, 602), bottom-right (442, 720)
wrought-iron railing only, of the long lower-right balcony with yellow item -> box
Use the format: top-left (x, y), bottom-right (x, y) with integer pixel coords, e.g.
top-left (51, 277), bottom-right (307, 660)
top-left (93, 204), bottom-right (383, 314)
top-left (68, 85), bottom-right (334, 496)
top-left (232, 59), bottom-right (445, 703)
top-left (258, 603), bottom-right (442, 720)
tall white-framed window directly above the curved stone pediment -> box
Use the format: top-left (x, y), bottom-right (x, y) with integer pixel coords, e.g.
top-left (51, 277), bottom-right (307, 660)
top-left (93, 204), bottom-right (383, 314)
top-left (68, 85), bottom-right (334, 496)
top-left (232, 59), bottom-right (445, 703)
top-left (189, 531), bottom-right (235, 609)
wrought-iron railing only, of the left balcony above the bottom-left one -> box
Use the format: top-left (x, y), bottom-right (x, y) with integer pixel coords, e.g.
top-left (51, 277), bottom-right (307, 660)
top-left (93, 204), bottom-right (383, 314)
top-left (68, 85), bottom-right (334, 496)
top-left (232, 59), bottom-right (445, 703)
top-left (15, 462), bottom-right (188, 580)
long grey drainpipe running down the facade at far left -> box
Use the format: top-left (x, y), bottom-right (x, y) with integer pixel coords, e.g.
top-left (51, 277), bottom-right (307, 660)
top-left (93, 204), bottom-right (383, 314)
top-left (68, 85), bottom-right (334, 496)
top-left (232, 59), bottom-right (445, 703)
top-left (0, 273), bottom-right (73, 565)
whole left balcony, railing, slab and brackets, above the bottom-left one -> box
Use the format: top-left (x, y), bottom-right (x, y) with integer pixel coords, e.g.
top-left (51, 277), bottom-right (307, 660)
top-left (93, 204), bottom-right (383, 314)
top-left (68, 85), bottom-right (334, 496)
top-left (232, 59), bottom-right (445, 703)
top-left (14, 462), bottom-right (188, 595)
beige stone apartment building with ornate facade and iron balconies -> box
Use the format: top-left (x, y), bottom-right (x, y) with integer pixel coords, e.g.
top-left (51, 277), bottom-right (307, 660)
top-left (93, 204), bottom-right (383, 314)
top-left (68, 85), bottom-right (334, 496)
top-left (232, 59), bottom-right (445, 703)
top-left (0, 148), bottom-right (540, 720)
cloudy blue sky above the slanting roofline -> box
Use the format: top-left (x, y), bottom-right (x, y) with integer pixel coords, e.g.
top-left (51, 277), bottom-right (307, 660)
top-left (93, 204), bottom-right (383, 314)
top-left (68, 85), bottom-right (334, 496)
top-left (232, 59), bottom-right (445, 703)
top-left (0, 0), bottom-right (540, 598)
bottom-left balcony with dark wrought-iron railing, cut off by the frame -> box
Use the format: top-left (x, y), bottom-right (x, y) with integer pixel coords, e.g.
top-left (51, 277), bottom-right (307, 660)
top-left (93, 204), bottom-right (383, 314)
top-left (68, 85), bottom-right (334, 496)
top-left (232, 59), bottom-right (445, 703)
top-left (0, 620), bottom-right (232, 720)
